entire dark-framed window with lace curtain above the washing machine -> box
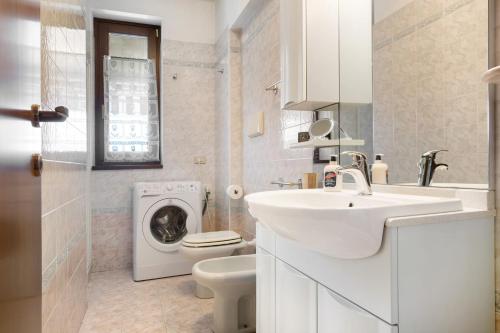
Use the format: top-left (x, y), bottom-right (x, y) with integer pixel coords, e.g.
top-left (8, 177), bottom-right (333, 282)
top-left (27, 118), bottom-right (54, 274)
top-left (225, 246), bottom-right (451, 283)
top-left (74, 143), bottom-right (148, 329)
top-left (94, 19), bottom-right (162, 170)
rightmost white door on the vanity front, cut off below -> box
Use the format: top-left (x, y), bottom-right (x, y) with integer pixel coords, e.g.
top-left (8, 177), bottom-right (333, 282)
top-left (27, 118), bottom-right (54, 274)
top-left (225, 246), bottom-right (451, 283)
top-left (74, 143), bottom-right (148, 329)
top-left (318, 285), bottom-right (398, 333)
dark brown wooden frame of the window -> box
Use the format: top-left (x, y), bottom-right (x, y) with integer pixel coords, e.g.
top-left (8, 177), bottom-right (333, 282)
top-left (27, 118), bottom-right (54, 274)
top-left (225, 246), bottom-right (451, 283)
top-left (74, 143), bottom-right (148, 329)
top-left (92, 18), bottom-right (163, 170)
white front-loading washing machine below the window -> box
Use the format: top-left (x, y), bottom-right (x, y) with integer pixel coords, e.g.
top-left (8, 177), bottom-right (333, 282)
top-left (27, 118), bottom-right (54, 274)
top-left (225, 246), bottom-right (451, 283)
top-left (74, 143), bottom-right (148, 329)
top-left (133, 182), bottom-right (202, 281)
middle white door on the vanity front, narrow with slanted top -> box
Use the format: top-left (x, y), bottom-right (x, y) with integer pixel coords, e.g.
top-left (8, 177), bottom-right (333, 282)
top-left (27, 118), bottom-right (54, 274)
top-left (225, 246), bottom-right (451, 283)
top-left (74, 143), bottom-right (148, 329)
top-left (274, 260), bottom-right (317, 333)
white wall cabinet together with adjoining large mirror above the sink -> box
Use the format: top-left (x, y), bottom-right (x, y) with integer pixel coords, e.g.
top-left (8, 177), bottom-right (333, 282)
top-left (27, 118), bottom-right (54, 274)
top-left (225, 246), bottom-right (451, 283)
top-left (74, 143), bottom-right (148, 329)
top-left (280, 0), bottom-right (494, 189)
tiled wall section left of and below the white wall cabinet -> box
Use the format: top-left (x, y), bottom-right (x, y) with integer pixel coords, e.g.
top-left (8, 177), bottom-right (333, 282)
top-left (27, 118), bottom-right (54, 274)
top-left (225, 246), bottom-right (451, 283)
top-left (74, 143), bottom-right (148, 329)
top-left (241, 0), bottom-right (313, 193)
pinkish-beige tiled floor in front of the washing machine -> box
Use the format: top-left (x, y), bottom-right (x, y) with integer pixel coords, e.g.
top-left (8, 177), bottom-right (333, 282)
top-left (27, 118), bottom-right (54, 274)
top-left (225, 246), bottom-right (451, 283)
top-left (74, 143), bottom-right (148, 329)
top-left (80, 270), bottom-right (213, 333)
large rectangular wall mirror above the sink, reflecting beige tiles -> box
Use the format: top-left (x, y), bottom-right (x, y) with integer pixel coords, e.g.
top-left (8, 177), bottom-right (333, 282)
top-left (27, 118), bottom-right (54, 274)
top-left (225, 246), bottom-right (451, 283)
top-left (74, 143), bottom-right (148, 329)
top-left (338, 0), bottom-right (491, 188)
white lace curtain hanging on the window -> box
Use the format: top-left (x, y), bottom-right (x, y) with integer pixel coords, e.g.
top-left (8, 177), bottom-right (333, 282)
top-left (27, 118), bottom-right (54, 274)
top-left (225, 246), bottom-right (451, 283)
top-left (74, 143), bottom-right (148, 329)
top-left (103, 56), bottom-right (160, 162)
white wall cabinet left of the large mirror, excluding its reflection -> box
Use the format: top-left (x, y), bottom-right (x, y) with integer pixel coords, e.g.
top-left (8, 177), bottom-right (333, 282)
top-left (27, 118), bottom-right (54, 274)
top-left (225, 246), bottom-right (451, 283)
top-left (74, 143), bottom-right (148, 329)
top-left (280, 0), bottom-right (340, 111)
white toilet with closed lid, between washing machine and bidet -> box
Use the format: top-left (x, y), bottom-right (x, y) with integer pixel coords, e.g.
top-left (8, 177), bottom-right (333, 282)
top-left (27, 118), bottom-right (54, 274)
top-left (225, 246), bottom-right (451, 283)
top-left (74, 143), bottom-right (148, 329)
top-left (180, 230), bottom-right (248, 298)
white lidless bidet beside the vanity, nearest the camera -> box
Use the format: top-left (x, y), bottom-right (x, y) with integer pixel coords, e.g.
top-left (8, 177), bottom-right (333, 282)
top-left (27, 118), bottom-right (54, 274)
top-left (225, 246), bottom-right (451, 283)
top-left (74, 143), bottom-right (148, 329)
top-left (193, 254), bottom-right (256, 333)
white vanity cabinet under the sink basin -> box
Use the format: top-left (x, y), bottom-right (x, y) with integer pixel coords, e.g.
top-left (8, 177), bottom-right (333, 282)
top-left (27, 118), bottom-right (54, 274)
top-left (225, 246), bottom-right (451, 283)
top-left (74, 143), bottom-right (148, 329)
top-left (257, 211), bottom-right (495, 333)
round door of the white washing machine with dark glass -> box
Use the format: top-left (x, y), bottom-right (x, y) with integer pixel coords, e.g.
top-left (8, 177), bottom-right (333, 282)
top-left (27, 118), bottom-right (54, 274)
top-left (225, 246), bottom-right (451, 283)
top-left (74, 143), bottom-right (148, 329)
top-left (142, 199), bottom-right (198, 252)
